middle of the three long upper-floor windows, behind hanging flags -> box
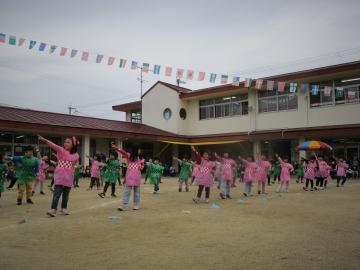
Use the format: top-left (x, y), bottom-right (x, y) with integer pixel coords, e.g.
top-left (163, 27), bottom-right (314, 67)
top-left (258, 91), bottom-right (298, 113)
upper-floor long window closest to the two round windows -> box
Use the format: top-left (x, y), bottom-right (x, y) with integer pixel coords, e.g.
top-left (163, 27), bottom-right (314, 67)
top-left (199, 94), bottom-right (248, 120)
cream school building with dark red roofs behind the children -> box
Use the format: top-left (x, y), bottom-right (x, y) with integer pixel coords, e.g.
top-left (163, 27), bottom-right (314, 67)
top-left (0, 61), bottom-right (360, 167)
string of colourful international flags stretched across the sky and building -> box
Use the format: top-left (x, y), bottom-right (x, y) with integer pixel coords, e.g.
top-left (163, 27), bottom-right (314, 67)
top-left (0, 33), bottom-right (356, 98)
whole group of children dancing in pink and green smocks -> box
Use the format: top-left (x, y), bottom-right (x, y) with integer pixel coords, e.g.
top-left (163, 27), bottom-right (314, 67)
top-left (0, 139), bottom-right (348, 217)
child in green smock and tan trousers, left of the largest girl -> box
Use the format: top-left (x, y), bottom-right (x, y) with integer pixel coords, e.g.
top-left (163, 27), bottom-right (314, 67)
top-left (11, 146), bottom-right (39, 205)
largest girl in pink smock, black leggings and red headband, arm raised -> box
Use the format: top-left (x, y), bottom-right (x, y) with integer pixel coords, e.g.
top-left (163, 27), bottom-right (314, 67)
top-left (39, 135), bottom-right (79, 217)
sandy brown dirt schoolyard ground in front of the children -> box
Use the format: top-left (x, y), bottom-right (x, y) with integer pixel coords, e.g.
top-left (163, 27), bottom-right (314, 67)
top-left (0, 178), bottom-right (360, 270)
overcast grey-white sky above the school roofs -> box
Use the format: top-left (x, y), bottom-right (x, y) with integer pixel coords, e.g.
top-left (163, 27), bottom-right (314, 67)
top-left (0, 0), bottom-right (360, 119)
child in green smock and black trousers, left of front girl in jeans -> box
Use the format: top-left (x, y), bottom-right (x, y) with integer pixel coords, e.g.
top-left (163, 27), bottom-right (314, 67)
top-left (98, 151), bottom-right (120, 198)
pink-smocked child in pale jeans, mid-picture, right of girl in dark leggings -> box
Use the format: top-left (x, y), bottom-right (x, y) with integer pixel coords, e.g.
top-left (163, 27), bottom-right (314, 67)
top-left (215, 153), bottom-right (236, 199)
